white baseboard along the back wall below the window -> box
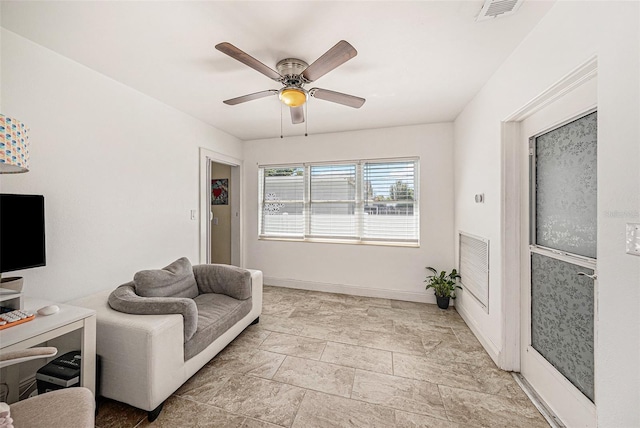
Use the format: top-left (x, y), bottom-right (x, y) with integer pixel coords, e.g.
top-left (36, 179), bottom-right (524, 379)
top-left (264, 276), bottom-right (442, 304)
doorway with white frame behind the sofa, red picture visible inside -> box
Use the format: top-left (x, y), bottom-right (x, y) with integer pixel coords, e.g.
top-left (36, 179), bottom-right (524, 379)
top-left (200, 148), bottom-right (243, 267)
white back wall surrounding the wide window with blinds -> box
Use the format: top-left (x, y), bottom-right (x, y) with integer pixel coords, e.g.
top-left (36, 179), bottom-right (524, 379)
top-left (244, 123), bottom-right (454, 302)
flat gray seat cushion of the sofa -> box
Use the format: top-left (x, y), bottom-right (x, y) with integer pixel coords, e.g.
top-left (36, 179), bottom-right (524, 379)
top-left (184, 293), bottom-right (252, 361)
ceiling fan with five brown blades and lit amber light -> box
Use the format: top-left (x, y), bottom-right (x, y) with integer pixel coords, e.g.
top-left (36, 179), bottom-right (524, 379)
top-left (216, 40), bottom-right (365, 124)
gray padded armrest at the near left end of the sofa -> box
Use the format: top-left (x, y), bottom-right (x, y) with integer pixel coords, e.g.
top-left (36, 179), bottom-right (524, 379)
top-left (108, 282), bottom-right (198, 342)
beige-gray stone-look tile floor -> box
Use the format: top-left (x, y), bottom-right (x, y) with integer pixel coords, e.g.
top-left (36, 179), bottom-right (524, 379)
top-left (96, 286), bottom-right (549, 428)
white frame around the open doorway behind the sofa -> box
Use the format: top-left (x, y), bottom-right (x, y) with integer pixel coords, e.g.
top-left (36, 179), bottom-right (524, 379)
top-left (198, 147), bottom-right (244, 267)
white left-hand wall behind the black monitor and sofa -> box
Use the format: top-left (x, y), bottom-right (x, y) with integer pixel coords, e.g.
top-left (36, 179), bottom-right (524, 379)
top-left (0, 30), bottom-right (242, 301)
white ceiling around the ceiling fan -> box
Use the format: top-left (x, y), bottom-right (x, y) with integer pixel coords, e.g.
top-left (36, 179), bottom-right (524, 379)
top-left (1, 0), bottom-right (553, 140)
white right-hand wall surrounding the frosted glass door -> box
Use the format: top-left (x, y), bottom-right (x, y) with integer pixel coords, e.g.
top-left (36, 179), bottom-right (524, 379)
top-left (454, 1), bottom-right (640, 428)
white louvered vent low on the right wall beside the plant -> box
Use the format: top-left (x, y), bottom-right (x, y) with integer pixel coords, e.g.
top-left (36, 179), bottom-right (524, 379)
top-left (459, 232), bottom-right (489, 313)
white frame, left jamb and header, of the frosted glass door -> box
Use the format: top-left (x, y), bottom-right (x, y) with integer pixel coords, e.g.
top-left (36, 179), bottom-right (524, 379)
top-left (498, 55), bottom-right (598, 372)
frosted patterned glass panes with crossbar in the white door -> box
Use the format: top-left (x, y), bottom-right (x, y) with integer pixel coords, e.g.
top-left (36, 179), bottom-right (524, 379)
top-left (527, 111), bottom-right (597, 414)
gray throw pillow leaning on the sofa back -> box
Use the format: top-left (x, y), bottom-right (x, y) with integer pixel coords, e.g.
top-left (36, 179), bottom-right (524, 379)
top-left (133, 257), bottom-right (198, 299)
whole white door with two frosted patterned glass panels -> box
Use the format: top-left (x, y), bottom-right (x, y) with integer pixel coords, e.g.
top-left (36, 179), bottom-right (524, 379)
top-left (521, 80), bottom-right (597, 427)
